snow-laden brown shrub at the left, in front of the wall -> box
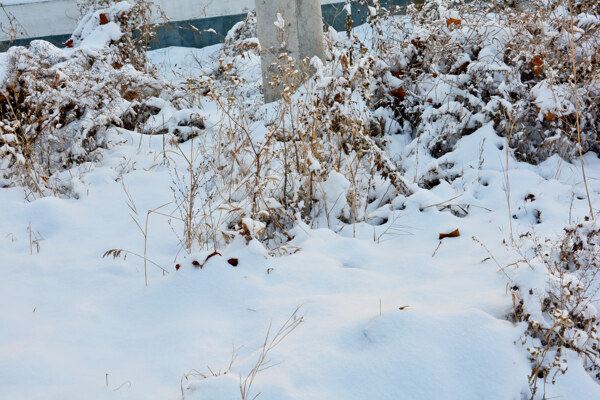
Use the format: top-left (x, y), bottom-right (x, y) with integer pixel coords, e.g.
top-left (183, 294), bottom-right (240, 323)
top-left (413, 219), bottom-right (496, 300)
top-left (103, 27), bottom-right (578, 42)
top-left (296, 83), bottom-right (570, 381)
top-left (0, 2), bottom-right (191, 195)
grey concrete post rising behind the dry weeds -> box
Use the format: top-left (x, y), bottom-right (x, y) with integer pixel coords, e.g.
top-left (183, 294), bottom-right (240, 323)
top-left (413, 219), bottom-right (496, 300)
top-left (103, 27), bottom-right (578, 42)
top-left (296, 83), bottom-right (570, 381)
top-left (255, 0), bottom-right (324, 103)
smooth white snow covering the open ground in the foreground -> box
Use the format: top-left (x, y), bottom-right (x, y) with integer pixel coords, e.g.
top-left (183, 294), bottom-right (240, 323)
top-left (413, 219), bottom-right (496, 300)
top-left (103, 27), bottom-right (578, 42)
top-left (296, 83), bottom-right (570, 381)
top-left (0, 1), bottom-right (600, 400)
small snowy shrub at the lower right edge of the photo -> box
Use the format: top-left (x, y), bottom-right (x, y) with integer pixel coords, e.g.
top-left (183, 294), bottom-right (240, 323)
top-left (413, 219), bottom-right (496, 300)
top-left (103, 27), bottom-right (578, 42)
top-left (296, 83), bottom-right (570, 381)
top-left (508, 222), bottom-right (600, 399)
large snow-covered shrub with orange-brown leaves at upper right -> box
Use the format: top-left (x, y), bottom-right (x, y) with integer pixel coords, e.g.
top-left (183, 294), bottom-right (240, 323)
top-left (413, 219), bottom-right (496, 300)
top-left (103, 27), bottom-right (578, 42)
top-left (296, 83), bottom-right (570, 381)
top-left (383, 0), bottom-right (600, 163)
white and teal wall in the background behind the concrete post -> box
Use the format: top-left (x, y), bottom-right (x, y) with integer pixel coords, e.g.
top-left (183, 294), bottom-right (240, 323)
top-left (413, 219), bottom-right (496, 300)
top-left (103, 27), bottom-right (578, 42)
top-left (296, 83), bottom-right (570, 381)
top-left (0, 0), bottom-right (410, 48)
